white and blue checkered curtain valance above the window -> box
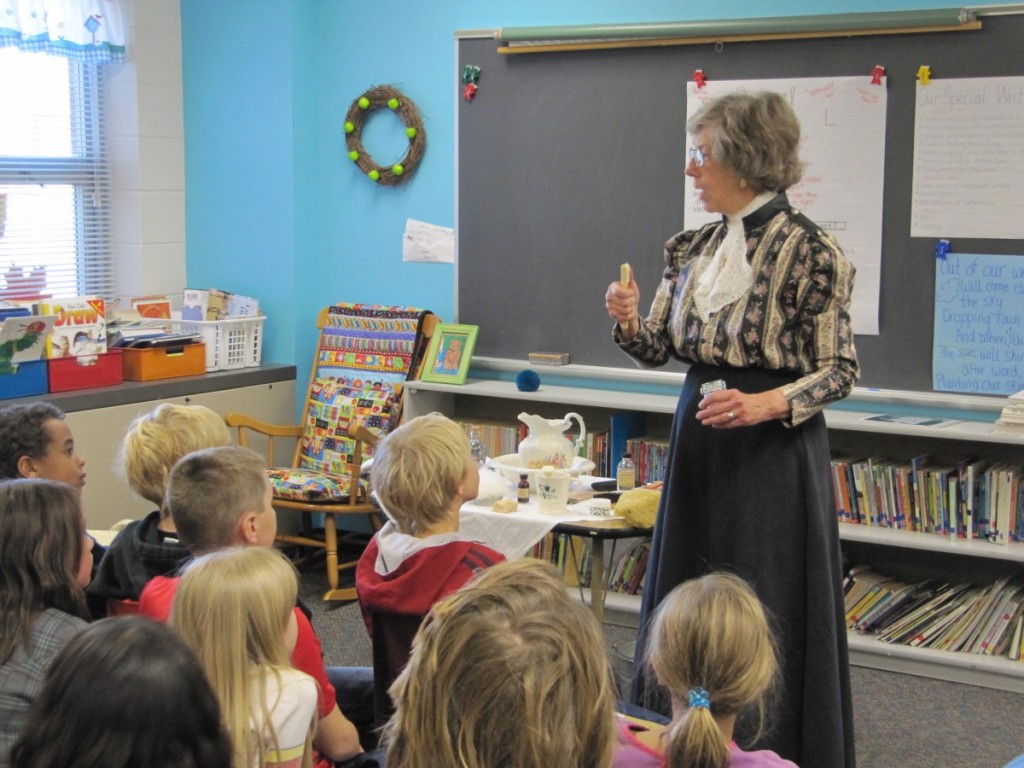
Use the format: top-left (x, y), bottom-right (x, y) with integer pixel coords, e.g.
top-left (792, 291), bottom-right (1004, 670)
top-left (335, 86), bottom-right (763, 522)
top-left (0, 0), bottom-right (125, 61)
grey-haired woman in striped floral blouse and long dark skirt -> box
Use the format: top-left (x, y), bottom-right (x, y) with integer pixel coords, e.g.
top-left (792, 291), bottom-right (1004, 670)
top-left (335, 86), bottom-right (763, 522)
top-left (605, 93), bottom-right (858, 768)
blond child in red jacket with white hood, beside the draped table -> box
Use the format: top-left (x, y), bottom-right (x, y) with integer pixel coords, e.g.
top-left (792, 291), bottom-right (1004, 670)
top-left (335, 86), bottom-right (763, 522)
top-left (355, 414), bottom-right (505, 726)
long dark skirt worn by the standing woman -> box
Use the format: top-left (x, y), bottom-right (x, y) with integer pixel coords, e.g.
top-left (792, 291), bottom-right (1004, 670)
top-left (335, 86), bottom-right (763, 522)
top-left (633, 365), bottom-right (855, 768)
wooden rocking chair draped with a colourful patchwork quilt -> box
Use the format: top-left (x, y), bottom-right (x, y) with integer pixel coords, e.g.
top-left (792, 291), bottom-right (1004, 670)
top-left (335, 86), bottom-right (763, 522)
top-left (225, 304), bottom-right (437, 600)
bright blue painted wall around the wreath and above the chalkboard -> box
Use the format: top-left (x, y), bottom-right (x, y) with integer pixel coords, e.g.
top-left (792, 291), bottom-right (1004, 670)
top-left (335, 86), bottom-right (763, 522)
top-left (181, 0), bottom-right (1015, 409)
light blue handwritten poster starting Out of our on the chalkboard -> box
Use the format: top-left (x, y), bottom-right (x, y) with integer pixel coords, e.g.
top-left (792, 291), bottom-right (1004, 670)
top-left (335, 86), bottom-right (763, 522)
top-left (932, 253), bottom-right (1024, 395)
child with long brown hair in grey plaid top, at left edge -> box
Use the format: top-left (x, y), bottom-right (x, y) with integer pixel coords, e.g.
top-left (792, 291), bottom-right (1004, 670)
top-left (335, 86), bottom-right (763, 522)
top-left (0, 478), bottom-right (93, 766)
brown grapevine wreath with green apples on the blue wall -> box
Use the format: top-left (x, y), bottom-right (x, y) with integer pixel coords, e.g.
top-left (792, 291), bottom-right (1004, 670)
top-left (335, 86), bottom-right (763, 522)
top-left (345, 85), bottom-right (427, 186)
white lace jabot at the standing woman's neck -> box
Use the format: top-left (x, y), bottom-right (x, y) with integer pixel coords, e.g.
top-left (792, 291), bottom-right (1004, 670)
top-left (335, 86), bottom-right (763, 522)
top-left (693, 191), bottom-right (777, 319)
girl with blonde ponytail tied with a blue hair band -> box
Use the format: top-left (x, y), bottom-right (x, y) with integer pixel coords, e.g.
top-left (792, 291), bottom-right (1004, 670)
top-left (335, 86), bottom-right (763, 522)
top-left (613, 572), bottom-right (796, 768)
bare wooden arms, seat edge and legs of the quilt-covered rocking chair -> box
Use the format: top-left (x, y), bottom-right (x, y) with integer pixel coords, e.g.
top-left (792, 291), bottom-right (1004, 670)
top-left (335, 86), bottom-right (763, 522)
top-left (224, 413), bottom-right (382, 600)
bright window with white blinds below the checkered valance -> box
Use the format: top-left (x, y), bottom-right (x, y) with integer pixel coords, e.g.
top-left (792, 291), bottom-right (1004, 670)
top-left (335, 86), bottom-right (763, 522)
top-left (0, 47), bottom-right (114, 299)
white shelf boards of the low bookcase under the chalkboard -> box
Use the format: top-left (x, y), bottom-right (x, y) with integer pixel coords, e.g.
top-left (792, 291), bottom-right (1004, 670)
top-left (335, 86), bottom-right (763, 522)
top-left (404, 357), bottom-right (1024, 692)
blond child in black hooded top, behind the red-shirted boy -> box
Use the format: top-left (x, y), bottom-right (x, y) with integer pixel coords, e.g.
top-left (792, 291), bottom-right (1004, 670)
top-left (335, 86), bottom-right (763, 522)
top-left (86, 402), bottom-right (231, 617)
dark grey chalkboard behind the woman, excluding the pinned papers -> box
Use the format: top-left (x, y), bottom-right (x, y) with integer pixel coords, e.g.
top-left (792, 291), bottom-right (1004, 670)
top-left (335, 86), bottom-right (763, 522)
top-left (456, 15), bottom-right (1024, 391)
